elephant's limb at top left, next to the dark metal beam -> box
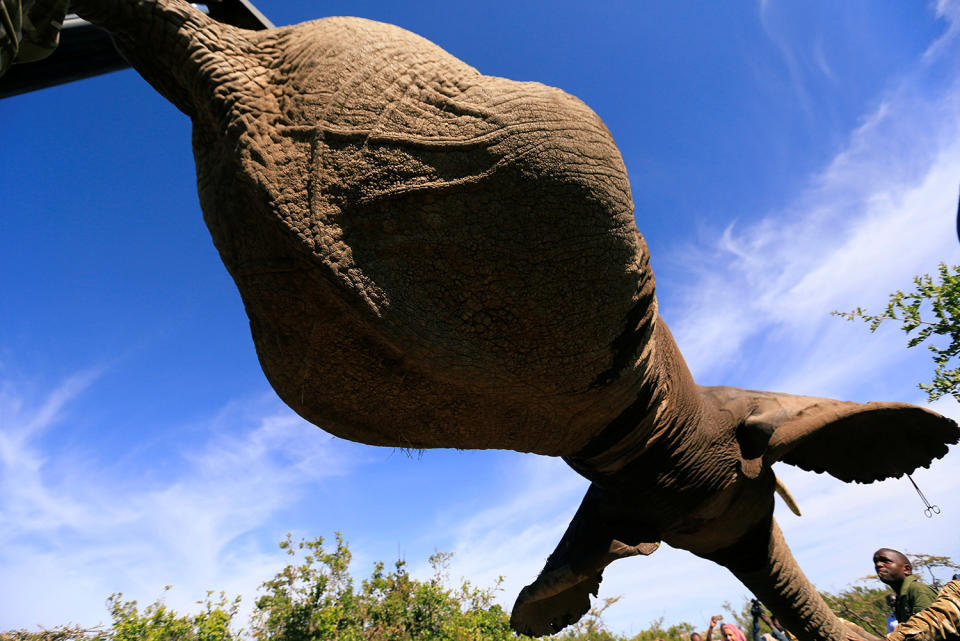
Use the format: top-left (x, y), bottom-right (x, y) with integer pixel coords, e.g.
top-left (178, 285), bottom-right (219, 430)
top-left (71, 0), bottom-right (262, 119)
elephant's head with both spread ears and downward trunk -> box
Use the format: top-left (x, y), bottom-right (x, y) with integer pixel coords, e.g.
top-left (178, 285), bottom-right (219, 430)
top-left (512, 387), bottom-right (960, 639)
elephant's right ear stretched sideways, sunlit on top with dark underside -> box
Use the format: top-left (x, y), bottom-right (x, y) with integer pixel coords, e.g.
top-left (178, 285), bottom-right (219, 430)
top-left (703, 387), bottom-right (960, 483)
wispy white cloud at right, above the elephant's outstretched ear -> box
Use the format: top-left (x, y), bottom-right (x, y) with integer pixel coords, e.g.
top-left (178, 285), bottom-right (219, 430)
top-left (662, 60), bottom-right (960, 391)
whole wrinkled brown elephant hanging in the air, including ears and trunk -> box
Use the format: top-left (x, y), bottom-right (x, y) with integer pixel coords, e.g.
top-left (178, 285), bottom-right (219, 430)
top-left (47, 0), bottom-right (958, 641)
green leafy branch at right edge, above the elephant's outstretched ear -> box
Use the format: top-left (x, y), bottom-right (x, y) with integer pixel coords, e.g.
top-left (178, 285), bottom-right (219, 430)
top-left (832, 263), bottom-right (960, 402)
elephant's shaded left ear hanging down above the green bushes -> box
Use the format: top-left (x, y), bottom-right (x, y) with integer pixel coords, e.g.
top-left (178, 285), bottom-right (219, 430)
top-left (510, 485), bottom-right (660, 637)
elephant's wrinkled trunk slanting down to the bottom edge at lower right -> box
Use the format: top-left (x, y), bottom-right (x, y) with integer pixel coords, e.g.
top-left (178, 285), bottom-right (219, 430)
top-left (707, 516), bottom-right (875, 641)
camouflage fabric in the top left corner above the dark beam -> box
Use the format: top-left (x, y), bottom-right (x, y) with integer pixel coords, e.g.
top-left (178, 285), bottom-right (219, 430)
top-left (0, 0), bottom-right (70, 75)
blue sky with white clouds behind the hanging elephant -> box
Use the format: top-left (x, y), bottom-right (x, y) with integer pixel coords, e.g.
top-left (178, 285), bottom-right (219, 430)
top-left (0, 0), bottom-right (960, 632)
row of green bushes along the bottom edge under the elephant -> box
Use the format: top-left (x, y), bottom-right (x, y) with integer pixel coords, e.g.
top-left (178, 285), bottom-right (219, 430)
top-left (0, 533), bottom-right (712, 641)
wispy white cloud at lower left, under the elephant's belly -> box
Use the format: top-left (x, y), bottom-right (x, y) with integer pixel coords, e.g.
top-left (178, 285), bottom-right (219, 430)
top-left (0, 373), bottom-right (364, 628)
